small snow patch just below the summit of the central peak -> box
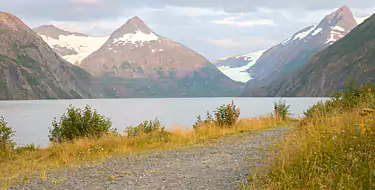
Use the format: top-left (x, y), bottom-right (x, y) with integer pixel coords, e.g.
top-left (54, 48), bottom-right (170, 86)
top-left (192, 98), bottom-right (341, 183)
top-left (113, 30), bottom-right (159, 46)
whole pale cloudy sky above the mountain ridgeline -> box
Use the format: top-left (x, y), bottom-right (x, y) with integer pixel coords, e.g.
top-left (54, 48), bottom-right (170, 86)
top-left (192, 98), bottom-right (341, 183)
top-left (0, 0), bottom-right (375, 60)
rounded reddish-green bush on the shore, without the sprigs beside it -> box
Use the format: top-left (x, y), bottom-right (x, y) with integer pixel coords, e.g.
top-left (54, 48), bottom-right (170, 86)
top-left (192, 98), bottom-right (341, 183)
top-left (215, 101), bottom-right (240, 127)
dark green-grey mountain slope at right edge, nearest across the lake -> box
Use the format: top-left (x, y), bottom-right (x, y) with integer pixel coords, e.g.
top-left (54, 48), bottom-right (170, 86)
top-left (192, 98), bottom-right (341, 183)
top-left (243, 15), bottom-right (375, 96)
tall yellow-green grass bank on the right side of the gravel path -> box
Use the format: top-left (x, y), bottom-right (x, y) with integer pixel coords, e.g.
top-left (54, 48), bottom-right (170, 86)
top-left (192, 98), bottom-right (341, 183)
top-left (244, 85), bottom-right (375, 189)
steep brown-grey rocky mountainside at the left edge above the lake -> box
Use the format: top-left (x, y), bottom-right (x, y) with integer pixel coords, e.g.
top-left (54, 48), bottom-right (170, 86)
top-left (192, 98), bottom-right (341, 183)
top-left (0, 12), bottom-right (92, 100)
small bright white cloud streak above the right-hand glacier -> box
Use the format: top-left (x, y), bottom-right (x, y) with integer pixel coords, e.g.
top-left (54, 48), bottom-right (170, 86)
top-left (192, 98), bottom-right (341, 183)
top-left (212, 17), bottom-right (276, 27)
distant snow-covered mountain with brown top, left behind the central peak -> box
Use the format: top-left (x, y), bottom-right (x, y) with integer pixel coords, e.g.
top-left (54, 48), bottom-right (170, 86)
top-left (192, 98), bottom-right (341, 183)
top-left (34, 25), bottom-right (109, 64)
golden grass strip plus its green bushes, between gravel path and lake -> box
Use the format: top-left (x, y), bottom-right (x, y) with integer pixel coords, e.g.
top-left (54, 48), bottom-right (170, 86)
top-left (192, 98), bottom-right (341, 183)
top-left (0, 103), bottom-right (282, 188)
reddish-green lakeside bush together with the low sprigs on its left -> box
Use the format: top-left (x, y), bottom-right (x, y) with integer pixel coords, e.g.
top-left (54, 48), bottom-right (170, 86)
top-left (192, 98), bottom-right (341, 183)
top-left (193, 101), bottom-right (240, 129)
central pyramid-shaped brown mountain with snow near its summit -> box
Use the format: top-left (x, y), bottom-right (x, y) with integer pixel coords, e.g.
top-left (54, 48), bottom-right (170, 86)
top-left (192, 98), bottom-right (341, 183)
top-left (80, 17), bottom-right (239, 97)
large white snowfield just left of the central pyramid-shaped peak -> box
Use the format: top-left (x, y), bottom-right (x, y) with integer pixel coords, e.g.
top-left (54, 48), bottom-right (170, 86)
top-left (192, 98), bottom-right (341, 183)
top-left (39, 34), bottom-right (109, 64)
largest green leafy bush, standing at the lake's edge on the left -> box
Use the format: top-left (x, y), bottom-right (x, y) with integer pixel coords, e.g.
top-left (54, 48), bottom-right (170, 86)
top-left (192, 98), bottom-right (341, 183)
top-left (49, 105), bottom-right (116, 142)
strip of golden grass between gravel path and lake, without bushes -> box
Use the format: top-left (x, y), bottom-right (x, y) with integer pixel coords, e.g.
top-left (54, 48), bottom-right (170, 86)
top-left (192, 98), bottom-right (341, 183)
top-left (0, 117), bottom-right (286, 188)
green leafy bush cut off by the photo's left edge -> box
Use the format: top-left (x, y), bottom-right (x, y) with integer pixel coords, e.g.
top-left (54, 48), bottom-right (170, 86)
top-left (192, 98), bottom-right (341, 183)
top-left (0, 117), bottom-right (16, 155)
